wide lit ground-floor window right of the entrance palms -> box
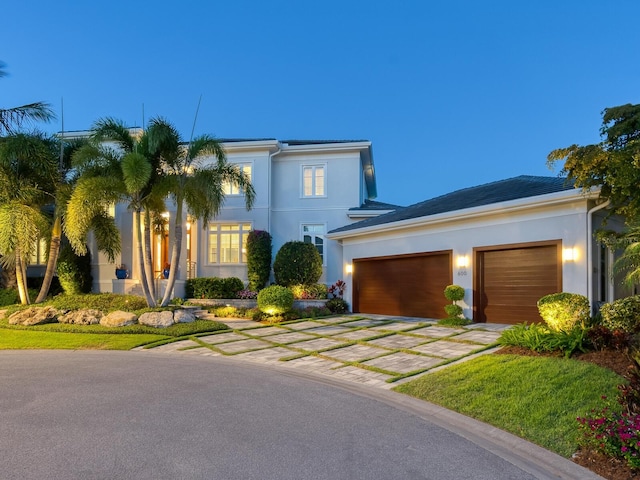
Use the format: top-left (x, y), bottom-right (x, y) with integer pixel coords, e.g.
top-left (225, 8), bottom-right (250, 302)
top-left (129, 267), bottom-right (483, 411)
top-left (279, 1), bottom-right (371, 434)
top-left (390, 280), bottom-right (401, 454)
top-left (209, 223), bottom-right (251, 263)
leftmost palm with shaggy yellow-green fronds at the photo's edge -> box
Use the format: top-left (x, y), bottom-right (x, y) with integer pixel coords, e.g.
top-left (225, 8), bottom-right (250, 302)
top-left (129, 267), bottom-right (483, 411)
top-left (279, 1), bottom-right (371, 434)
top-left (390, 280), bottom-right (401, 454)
top-left (0, 133), bottom-right (57, 304)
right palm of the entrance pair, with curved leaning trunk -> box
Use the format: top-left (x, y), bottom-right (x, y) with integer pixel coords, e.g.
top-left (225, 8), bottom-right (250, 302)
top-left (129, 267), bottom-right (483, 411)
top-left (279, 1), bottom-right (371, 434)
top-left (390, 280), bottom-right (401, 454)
top-left (146, 117), bottom-right (255, 306)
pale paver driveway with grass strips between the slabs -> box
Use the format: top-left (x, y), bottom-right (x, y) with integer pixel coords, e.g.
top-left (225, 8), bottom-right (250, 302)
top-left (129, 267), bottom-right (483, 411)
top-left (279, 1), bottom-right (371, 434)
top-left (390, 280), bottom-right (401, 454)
top-left (139, 314), bottom-right (509, 389)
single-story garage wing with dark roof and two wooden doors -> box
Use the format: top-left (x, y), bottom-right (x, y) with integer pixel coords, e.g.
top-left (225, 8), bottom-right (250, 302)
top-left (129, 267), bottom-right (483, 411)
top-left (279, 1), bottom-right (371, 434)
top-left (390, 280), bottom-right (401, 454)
top-left (327, 176), bottom-right (626, 323)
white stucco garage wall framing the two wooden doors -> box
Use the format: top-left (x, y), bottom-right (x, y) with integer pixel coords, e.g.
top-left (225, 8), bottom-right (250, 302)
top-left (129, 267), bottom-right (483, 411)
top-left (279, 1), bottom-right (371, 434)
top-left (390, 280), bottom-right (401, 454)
top-left (332, 200), bottom-right (591, 318)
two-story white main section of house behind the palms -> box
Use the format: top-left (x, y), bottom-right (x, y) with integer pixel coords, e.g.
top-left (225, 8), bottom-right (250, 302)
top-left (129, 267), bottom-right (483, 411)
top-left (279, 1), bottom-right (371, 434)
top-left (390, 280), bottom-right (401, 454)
top-left (84, 139), bottom-right (397, 296)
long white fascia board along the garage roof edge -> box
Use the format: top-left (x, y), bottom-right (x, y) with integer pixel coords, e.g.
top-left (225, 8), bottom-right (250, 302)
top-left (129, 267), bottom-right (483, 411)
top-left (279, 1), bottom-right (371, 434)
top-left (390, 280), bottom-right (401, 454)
top-left (325, 189), bottom-right (599, 240)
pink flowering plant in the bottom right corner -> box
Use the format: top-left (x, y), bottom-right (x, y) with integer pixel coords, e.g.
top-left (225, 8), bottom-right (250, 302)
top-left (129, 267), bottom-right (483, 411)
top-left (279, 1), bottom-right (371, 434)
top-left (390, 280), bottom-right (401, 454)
top-left (577, 397), bottom-right (640, 468)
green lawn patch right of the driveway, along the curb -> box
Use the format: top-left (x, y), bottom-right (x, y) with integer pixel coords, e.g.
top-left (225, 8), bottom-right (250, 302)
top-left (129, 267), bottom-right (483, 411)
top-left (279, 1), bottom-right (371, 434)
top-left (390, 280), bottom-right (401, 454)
top-left (394, 355), bottom-right (623, 457)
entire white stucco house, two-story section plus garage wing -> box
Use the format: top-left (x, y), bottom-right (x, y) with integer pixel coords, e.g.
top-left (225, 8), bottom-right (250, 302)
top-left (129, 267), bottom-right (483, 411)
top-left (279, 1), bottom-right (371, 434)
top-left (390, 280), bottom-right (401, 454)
top-left (42, 130), bottom-right (628, 323)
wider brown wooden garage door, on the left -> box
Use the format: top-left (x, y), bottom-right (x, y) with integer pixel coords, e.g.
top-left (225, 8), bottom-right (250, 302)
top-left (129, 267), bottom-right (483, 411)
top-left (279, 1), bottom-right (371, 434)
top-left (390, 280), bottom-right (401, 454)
top-left (353, 251), bottom-right (451, 318)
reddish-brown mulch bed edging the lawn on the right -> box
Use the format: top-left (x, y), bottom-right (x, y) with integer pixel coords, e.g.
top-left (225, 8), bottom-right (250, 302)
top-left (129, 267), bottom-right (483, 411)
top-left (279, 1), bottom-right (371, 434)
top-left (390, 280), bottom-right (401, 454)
top-left (496, 347), bottom-right (640, 480)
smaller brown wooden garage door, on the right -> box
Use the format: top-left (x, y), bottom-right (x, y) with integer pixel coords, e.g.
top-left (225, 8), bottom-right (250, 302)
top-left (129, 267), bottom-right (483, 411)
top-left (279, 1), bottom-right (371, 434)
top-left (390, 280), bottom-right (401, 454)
top-left (473, 241), bottom-right (562, 324)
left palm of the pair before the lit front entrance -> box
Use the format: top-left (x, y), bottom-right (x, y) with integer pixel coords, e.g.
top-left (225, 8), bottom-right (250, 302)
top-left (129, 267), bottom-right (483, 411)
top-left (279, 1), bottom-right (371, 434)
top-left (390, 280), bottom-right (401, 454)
top-left (65, 118), bottom-right (164, 306)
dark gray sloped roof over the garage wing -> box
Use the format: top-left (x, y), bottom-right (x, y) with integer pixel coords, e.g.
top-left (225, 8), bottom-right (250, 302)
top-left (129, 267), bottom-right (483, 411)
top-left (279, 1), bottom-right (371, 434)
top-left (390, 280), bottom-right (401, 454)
top-left (329, 175), bottom-right (575, 233)
